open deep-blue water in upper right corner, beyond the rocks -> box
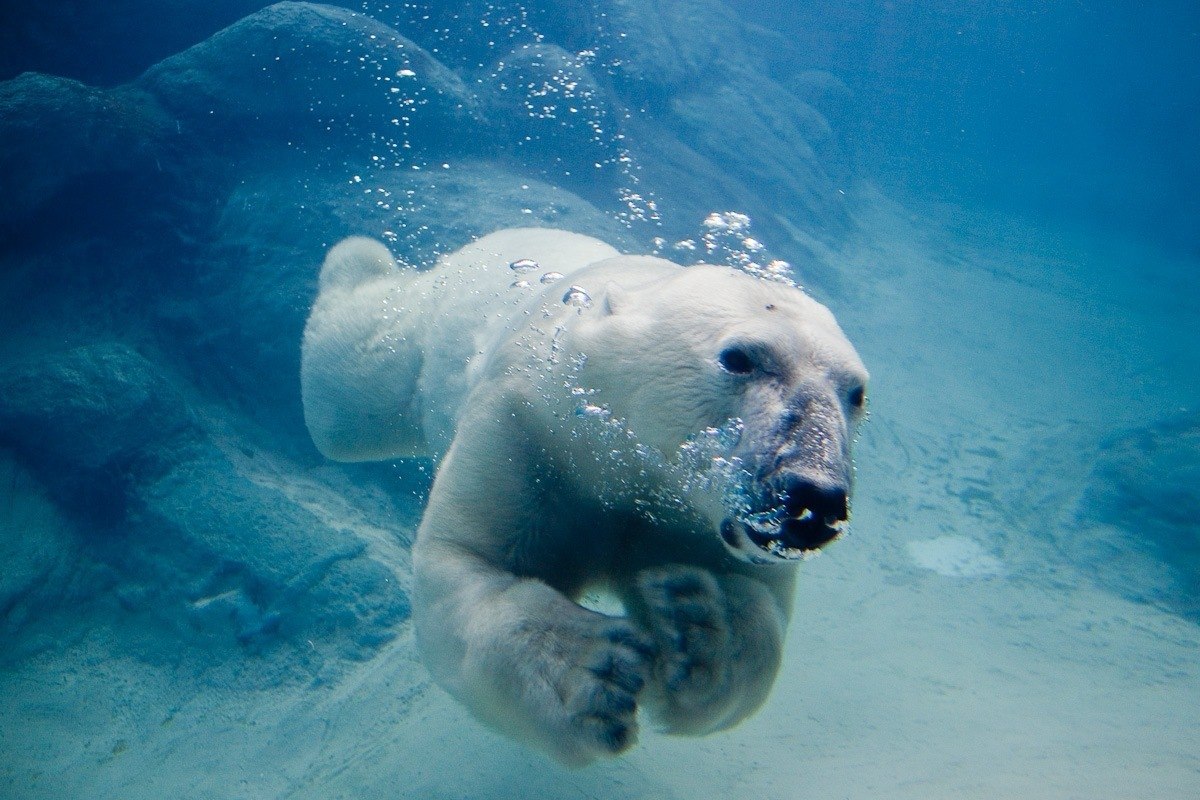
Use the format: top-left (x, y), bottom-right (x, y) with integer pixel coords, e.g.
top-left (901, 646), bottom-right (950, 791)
top-left (732, 0), bottom-right (1200, 254)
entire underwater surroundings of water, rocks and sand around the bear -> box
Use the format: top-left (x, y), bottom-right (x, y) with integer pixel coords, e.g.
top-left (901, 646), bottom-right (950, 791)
top-left (0, 0), bottom-right (1200, 800)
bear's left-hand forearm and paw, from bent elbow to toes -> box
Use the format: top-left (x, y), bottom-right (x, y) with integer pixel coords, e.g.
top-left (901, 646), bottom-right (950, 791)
top-left (414, 545), bottom-right (653, 765)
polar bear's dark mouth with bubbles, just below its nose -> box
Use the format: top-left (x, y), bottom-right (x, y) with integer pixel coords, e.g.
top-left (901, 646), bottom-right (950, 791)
top-left (721, 507), bottom-right (848, 564)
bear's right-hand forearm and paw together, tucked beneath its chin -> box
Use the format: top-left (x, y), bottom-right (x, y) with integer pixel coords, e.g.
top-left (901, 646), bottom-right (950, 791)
top-left (630, 565), bottom-right (787, 735)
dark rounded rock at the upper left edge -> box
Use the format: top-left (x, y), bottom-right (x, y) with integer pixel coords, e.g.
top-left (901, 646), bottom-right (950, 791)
top-left (0, 72), bottom-right (173, 230)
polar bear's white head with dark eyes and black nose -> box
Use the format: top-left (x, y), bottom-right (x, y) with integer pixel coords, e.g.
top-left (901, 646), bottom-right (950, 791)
top-left (571, 259), bottom-right (868, 563)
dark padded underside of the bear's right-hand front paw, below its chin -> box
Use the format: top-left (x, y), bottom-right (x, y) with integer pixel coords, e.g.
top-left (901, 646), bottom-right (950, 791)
top-left (637, 566), bottom-right (733, 733)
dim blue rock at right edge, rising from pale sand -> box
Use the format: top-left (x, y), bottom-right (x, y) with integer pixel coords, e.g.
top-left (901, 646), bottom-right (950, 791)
top-left (1067, 415), bottom-right (1200, 621)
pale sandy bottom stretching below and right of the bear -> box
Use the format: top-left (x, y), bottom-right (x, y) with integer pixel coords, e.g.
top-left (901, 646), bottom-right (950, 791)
top-left (0, 195), bottom-right (1200, 800)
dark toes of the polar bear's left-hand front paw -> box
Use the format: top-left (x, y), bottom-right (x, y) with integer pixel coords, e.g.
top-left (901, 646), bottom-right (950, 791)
top-left (558, 620), bottom-right (655, 762)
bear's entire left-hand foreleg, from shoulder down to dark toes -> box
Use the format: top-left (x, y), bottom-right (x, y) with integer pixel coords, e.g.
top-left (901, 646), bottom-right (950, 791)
top-left (413, 410), bottom-right (654, 765)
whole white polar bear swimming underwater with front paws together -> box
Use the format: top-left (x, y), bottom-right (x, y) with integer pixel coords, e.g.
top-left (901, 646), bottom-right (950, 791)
top-left (301, 229), bottom-right (868, 765)
